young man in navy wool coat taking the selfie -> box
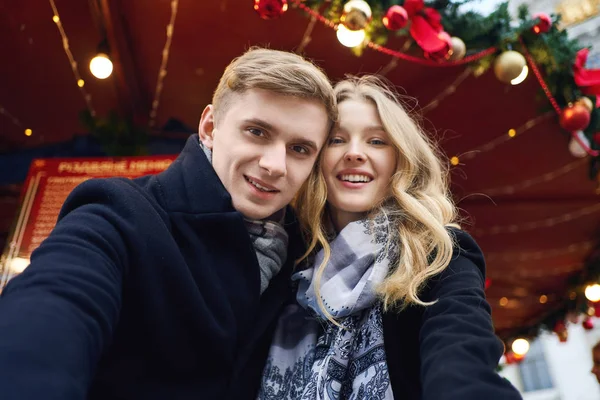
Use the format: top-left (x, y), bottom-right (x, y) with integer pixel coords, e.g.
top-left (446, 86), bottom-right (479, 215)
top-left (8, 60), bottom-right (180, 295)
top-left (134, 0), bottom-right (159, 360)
top-left (0, 49), bottom-right (336, 400)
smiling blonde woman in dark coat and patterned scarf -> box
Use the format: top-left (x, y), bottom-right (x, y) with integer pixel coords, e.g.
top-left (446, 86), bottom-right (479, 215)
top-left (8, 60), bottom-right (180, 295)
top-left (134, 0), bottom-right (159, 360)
top-left (259, 76), bottom-right (521, 400)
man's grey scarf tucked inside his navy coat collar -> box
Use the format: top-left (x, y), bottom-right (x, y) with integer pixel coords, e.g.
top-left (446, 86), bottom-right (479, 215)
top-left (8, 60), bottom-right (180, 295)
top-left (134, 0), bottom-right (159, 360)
top-left (200, 142), bottom-right (288, 294)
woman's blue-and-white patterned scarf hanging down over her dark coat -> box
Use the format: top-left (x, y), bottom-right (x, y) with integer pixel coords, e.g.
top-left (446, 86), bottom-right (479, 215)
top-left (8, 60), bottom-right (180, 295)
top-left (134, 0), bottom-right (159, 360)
top-left (258, 214), bottom-right (399, 400)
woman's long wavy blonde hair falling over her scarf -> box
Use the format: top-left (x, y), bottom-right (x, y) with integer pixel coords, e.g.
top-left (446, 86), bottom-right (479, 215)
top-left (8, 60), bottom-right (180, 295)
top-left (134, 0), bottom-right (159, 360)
top-left (294, 75), bottom-right (458, 322)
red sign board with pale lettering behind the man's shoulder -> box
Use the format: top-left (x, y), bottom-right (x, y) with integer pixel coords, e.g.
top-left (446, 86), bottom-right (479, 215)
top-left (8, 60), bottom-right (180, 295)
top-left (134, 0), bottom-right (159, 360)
top-left (0, 155), bottom-right (176, 291)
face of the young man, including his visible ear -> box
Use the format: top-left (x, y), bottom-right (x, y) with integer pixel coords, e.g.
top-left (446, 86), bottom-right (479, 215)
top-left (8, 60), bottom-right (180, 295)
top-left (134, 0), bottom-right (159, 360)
top-left (199, 89), bottom-right (329, 219)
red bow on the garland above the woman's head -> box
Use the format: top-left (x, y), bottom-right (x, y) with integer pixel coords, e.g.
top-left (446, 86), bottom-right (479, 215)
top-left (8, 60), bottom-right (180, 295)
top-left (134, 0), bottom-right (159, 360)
top-left (404, 0), bottom-right (448, 53)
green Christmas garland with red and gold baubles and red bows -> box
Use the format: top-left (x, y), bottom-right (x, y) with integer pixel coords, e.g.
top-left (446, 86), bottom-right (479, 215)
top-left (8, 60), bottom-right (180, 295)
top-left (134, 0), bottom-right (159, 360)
top-left (254, 0), bottom-right (600, 179)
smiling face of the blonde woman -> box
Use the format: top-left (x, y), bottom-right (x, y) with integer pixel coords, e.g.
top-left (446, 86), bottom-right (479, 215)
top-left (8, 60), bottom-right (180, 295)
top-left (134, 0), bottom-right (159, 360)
top-left (322, 100), bottom-right (398, 231)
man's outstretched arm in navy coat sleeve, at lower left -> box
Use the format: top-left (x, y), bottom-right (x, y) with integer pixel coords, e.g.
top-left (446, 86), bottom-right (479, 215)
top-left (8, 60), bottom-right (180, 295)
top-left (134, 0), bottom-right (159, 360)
top-left (0, 181), bottom-right (134, 400)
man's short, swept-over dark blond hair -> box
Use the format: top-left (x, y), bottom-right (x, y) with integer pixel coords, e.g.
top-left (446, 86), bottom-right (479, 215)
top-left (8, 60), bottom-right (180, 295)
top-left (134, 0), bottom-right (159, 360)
top-left (212, 47), bottom-right (337, 123)
